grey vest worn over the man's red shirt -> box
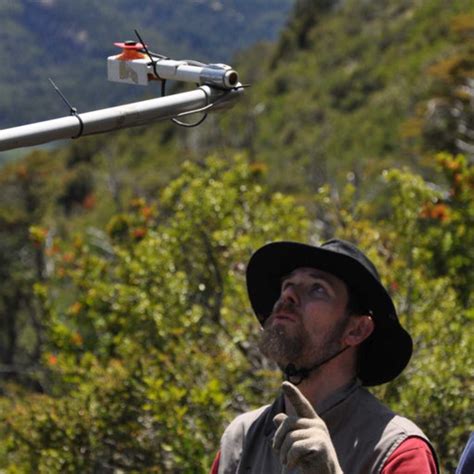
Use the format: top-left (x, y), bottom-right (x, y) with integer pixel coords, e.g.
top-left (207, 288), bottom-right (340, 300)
top-left (219, 382), bottom-right (436, 474)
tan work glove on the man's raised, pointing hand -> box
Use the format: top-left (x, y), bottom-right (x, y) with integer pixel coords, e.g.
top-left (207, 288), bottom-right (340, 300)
top-left (273, 382), bottom-right (343, 474)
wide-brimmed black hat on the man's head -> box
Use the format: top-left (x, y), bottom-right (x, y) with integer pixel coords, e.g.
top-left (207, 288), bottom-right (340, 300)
top-left (247, 239), bottom-right (413, 386)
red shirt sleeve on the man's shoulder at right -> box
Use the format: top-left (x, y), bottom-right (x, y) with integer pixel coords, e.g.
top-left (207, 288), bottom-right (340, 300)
top-left (381, 437), bottom-right (438, 474)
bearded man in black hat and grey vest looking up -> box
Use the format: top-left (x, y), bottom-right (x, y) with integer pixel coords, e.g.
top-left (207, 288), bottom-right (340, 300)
top-left (211, 239), bottom-right (438, 474)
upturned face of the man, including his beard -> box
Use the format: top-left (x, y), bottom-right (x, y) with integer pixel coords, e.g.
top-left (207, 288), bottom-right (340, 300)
top-left (259, 267), bottom-right (348, 368)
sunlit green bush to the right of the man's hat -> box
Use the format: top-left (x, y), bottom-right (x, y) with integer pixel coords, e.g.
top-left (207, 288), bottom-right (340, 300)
top-left (315, 161), bottom-right (474, 472)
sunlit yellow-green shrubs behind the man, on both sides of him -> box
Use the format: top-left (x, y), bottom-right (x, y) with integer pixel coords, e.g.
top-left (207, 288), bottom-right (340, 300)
top-left (2, 154), bottom-right (474, 472)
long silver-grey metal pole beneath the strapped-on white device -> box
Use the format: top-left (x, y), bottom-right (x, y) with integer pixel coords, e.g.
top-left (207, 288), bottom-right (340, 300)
top-left (0, 84), bottom-right (243, 151)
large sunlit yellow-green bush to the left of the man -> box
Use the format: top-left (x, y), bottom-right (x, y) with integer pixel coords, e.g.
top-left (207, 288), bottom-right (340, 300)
top-left (0, 158), bottom-right (308, 472)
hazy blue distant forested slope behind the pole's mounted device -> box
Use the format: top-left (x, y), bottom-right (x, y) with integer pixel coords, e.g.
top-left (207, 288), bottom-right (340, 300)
top-left (0, 0), bottom-right (293, 128)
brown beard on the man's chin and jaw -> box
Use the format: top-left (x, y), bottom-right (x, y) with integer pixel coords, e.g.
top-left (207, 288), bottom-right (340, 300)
top-left (258, 304), bottom-right (349, 370)
